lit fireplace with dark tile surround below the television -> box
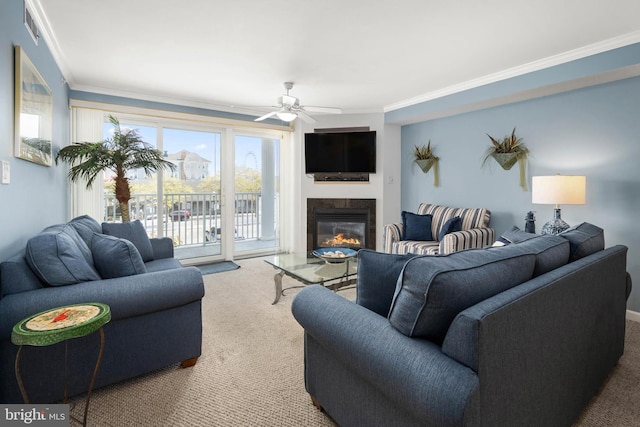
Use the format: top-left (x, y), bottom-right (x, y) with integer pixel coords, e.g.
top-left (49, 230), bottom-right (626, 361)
top-left (307, 199), bottom-right (376, 254)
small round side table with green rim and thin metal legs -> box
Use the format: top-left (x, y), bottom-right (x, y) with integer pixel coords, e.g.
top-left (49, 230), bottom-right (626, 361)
top-left (11, 302), bottom-right (111, 426)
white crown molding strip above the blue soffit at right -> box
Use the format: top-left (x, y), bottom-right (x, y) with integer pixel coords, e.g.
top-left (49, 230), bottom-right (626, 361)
top-left (384, 31), bottom-right (640, 113)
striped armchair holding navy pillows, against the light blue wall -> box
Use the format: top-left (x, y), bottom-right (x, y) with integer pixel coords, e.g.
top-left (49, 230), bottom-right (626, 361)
top-left (384, 203), bottom-right (495, 255)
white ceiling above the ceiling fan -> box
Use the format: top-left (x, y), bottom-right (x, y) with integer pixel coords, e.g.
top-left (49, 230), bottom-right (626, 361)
top-left (32, 0), bottom-right (640, 115)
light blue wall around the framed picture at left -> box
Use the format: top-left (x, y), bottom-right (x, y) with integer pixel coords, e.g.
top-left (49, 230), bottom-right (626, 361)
top-left (0, 0), bottom-right (69, 260)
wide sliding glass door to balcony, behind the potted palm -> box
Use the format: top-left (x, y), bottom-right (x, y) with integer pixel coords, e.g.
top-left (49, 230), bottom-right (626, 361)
top-left (103, 116), bottom-right (282, 264)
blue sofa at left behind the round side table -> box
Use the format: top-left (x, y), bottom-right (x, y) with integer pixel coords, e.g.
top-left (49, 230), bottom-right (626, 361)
top-left (0, 216), bottom-right (204, 403)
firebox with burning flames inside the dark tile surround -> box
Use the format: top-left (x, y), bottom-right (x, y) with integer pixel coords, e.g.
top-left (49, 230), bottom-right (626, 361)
top-left (313, 208), bottom-right (369, 250)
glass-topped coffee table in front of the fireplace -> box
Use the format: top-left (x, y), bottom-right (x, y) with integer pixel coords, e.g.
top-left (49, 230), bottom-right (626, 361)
top-left (265, 254), bottom-right (358, 304)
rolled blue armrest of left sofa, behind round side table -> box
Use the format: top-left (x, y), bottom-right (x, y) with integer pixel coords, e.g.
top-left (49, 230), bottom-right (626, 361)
top-left (0, 267), bottom-right (204, 341)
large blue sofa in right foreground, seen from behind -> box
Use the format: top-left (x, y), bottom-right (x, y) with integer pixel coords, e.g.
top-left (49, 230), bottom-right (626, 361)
top-left (292, 224), bottom-right (631, 427)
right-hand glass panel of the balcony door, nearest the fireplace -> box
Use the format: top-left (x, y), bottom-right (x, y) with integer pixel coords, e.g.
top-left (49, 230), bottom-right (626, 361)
top-left (233, 135), bottom-right (280, 255)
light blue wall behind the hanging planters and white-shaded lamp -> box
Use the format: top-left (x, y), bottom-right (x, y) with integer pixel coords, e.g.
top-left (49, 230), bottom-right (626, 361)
top-left (398, 77), bottom-right (640, 312)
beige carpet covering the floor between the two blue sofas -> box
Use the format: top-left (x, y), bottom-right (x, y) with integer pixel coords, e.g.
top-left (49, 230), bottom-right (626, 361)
top-left (73, 259), bottom-right (640, 427)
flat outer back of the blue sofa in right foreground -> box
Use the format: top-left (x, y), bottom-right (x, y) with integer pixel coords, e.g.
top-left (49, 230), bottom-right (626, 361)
top-left (442, 246), bottom-right (627, 426)
